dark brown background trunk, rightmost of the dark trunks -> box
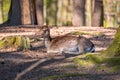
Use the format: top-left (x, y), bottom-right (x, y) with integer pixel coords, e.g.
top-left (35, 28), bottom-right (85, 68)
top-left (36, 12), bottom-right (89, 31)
top-left (92, 0), bottom-right (103, 27)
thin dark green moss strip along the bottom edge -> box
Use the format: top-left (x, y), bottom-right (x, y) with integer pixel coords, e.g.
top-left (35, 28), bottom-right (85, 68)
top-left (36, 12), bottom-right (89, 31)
top-left (41, 73), bottom-right (88, 80)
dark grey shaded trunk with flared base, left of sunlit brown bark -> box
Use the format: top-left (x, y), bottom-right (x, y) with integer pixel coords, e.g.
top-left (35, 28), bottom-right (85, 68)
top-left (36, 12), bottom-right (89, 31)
top-left (0, 0), bottom-right (21, 26)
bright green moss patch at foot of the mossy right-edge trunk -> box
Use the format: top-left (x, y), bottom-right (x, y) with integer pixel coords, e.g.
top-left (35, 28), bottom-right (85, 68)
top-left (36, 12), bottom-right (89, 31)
top-left (74, 54), bottom-right (120, 72)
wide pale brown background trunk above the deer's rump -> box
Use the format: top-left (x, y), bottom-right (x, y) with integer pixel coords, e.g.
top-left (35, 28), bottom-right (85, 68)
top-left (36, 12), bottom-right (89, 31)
top-left (72, 0), bottom-right (85, 26)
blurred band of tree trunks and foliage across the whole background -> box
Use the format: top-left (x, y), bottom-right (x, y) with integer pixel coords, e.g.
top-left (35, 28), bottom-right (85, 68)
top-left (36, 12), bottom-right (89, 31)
top-left (0, 0), bottom-right (120, 27)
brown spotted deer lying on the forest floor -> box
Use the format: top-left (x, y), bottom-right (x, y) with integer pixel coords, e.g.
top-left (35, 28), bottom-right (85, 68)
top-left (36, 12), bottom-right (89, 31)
top-left (41, 26), bottom-right (95, 55)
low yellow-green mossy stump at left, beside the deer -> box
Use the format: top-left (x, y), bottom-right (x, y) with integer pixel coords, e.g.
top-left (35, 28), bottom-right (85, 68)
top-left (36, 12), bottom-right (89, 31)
top-left (0, 36), bottom-right (30, 50)
